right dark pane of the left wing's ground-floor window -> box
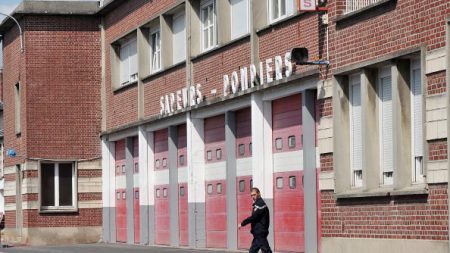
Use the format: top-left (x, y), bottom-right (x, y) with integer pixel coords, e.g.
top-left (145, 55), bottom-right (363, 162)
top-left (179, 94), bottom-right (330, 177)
top-left (59, 163), bottom-right (73, 206)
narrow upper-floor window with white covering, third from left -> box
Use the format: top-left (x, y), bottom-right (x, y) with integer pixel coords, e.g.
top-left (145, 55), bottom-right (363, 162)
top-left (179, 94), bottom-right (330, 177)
top-left (172, 12), bottom-right (186, 64)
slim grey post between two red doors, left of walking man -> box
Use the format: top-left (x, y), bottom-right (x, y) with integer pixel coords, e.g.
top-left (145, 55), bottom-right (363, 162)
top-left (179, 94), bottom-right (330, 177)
top-left (225, 112), bottom-right (238, 250)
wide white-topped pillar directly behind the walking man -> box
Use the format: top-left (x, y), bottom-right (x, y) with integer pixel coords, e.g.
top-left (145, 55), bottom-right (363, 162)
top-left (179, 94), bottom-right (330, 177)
top-left (251, 93), bottom-right (274, 246)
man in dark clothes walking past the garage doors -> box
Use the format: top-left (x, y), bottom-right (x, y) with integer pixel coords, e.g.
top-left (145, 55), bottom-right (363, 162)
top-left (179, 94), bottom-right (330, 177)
top-left (238, 187), bottom-right (272, 253)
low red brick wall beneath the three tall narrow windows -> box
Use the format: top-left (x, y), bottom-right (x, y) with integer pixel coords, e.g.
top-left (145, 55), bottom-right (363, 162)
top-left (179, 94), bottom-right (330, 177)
top-left (320, 184), bottom-right (448, 240)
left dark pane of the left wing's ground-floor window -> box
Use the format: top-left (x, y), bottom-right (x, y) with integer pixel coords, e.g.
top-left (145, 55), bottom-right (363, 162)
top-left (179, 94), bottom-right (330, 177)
top-left (41, 163), bottom-right (55, 206)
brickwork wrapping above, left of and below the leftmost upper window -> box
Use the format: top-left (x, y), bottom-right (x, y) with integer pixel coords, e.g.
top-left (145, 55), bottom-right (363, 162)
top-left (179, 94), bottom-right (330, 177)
top-left (105, 0), bottom-right (177, 129)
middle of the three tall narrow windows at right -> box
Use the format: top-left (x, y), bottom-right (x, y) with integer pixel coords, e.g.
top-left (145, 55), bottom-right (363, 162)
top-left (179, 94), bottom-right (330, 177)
top-left (378, 68), bottom-right (394, 185)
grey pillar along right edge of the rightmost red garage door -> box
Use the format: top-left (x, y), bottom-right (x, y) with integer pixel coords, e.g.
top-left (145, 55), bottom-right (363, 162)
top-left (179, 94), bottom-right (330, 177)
top-left (302, 90), bottom-right (318, 253)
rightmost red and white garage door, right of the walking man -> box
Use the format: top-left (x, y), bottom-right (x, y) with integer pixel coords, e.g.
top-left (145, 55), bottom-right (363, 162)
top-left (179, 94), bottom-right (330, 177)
top-left (272, 94), bottom-right (305, 252)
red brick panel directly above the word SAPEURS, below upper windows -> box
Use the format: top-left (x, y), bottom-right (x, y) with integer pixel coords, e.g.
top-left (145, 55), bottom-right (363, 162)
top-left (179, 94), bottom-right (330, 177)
top-left (144, 66), bottom-right (186, 117)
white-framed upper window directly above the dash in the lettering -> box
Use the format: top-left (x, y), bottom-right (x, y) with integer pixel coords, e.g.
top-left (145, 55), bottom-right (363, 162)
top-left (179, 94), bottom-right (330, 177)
top-left (200, 0), bottom-right (217, 52)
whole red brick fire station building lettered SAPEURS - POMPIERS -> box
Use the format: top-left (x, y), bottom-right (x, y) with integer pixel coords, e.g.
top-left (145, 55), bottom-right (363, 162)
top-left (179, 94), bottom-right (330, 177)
top-left (3, 0), bottom-right (450, 253)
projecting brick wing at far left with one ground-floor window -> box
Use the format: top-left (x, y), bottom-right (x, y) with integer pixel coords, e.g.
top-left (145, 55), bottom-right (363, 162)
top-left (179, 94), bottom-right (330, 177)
top-left (0, 1), bottom-right (102, 244)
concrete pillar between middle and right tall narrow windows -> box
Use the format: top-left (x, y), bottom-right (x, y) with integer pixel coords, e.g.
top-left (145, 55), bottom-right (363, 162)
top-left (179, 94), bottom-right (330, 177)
top-left (392, 60), bottom-right (412, 189)
